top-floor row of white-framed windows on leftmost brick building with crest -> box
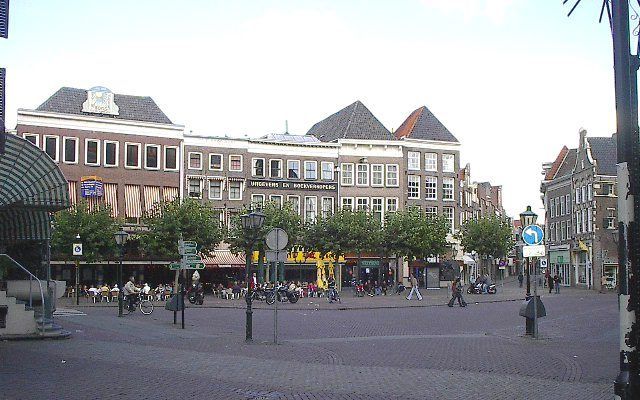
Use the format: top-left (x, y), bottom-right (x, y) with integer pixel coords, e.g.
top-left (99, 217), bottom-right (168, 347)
top-left (24, 133), bottom-right (178, 171)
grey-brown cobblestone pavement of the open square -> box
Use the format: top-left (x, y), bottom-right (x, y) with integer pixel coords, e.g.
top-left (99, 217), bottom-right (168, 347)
top-left (0, 282), bottom-right (618, 399)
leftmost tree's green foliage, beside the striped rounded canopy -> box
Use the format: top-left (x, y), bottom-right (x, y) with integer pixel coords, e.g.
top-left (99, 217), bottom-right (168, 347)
top-left (51, 202), bottom-right (119, 262)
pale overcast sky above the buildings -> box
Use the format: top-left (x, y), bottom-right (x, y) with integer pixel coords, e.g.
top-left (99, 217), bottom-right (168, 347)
top-left (0, 0), bottom-right (615, 217)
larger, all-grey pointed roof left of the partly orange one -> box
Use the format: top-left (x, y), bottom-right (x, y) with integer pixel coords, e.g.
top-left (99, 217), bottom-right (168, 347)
top-left (307, 100), bottom-right (395, 142)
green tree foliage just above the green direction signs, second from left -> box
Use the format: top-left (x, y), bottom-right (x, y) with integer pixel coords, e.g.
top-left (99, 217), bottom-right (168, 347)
top-left (140, 198), bottom-right (223, 260)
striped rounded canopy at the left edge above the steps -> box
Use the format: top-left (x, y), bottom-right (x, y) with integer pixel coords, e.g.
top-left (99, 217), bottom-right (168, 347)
top-left (0, 133), bottom-right (70, 243)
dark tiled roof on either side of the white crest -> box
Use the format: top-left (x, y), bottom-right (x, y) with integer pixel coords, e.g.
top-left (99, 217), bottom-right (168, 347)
top-left (36, 87), bottom-right (172, 124)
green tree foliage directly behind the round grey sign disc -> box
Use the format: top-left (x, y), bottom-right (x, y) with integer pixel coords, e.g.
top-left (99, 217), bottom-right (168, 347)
top-left (226, 202), bottom-right (302, 254)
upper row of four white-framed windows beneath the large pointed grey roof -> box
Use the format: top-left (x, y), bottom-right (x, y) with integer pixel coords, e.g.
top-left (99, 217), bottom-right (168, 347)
top-left (340, 163), bottom-right (399, 187)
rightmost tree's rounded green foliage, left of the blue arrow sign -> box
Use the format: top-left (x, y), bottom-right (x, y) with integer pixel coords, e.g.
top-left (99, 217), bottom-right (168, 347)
top-left (458, 216), bottom-right (513, 258)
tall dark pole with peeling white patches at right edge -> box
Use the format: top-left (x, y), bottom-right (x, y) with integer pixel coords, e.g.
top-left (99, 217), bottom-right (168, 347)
top-left (611, 0), bottom-right (640, 400)
